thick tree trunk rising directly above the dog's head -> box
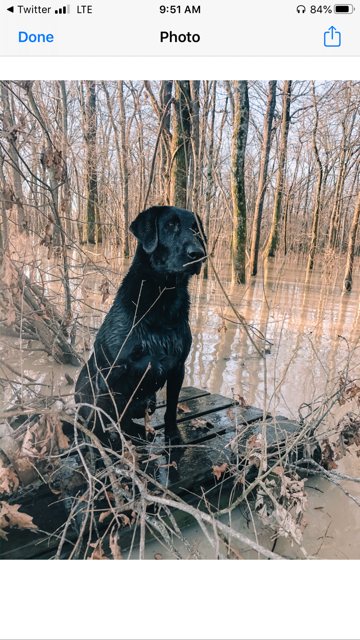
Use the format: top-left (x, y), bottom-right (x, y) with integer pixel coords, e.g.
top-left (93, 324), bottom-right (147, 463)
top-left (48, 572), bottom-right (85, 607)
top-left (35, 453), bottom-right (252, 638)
top-left (170, 80), bottom-right (191, 209)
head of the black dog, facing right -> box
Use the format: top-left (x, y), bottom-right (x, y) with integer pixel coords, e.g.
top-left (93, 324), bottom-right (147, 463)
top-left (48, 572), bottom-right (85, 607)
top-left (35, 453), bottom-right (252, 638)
top-left (130, 207), bottom-right (206, 275)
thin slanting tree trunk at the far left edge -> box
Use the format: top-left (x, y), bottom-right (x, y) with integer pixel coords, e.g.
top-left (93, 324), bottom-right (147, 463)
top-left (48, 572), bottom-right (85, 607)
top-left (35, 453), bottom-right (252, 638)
top-left (1, 82), bottom-right (27, 233)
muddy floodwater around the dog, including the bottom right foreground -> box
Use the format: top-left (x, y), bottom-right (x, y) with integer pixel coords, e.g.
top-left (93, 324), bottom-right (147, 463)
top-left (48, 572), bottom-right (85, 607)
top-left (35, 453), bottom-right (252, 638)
top-left (2, 248), bottom-right (360, 559)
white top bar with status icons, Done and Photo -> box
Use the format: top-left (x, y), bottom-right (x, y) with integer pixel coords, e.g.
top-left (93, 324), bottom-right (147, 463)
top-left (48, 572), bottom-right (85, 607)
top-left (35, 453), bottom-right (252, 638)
top-left (0, 0), bottom-right (360, 57)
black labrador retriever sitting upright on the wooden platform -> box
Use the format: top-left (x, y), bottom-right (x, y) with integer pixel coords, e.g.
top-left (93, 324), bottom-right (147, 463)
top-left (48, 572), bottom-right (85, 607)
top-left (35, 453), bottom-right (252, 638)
top-left (75, 206), bottom-right (206, 442)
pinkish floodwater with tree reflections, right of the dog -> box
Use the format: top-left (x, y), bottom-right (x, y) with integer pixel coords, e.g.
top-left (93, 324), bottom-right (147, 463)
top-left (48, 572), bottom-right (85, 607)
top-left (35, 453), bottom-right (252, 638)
top-left (185, 266), bottom-right (360, 415)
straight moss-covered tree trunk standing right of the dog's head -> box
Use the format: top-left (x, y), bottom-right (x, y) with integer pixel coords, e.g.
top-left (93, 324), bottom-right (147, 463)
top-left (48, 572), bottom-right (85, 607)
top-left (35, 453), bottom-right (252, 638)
top-left (231, 80), bottom-right (249, 284)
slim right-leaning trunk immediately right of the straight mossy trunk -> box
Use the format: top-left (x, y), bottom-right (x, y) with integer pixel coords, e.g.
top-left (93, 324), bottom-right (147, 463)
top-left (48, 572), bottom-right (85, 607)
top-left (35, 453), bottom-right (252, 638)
top-left (250, 80), bottom-right (276, 276)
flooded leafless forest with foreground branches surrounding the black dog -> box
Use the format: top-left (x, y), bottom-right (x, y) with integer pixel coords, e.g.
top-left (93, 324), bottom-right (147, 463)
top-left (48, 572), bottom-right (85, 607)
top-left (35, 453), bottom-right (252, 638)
top-left (0, 80), bottom-right (360, 560)
